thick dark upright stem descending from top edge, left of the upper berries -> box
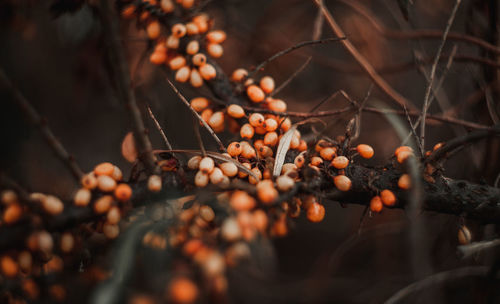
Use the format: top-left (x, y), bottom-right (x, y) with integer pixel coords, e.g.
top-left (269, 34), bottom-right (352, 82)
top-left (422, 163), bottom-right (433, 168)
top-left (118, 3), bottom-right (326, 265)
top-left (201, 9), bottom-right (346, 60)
top-left (100, 0), bottom-right (160, 173)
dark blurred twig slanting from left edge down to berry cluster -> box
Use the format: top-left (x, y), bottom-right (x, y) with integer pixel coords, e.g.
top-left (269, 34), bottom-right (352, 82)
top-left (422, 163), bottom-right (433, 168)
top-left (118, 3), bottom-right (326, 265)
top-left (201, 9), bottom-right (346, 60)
top-left (0, 68), bottom-right (84, 181)
